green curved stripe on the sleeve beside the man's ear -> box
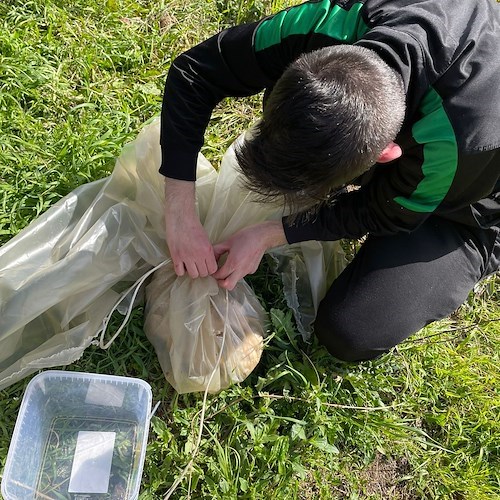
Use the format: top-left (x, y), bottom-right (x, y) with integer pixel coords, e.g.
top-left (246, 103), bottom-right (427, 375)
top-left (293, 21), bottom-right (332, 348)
top-left (394, 88), bottom-right (458, 213)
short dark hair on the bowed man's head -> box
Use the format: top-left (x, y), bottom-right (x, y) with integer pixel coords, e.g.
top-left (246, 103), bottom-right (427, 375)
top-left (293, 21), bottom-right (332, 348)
top-left (236, 45), bottom-right (405, 211)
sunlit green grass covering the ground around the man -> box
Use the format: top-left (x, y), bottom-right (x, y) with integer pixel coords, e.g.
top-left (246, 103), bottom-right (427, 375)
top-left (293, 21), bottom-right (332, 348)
top-left (0, 0), bottom-right (500, 500)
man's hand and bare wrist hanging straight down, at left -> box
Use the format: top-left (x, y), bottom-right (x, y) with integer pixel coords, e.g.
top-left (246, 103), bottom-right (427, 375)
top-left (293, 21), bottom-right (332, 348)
top-left (165, 178), bottom-right (217, 278)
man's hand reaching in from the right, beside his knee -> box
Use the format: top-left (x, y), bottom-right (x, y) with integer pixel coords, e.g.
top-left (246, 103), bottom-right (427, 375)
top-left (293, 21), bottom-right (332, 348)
top-left (213, 221), bottom-right (287, 290)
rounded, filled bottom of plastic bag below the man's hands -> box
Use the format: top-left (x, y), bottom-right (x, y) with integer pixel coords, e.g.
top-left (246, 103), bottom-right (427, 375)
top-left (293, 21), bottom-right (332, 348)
top-left (144, 266), bottom-right (265, 393)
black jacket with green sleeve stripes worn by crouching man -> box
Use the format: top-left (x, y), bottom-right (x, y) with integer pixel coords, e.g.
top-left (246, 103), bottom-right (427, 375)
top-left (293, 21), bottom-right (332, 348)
top-left (160, 0), bottom-right (500, 243)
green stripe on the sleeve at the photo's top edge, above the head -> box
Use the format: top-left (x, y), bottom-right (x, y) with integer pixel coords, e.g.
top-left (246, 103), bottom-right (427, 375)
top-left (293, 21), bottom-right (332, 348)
top-left (255, 0), bottom-right (368, 51)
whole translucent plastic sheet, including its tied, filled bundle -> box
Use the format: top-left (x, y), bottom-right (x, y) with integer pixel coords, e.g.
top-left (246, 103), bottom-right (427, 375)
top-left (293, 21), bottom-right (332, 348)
top-left (0, 118), bottom-right (342, 392)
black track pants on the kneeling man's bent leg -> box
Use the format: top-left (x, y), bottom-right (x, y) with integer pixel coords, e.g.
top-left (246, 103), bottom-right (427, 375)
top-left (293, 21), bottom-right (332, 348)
top-left (314, 217), bottom-right (500, 361)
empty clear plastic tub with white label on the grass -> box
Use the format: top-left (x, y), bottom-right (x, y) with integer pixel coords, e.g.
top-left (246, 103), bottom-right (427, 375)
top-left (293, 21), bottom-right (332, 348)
top-left (2, 370), bottom-right (152, 500)
